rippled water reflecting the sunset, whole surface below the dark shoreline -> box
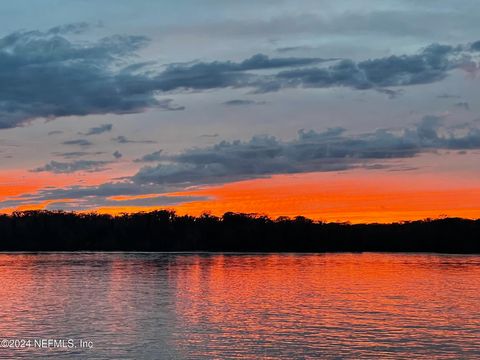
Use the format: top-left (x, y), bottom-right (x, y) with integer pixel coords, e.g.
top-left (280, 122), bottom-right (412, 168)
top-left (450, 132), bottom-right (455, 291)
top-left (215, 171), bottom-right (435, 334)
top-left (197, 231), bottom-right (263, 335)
top-left (0, 253), bottom-right (480, 359)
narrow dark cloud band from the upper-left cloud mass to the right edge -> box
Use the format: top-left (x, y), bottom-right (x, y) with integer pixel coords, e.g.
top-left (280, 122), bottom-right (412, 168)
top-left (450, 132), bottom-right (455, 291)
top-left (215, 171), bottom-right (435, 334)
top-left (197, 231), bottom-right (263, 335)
top-left (155, 44), bottom-right (477, 97)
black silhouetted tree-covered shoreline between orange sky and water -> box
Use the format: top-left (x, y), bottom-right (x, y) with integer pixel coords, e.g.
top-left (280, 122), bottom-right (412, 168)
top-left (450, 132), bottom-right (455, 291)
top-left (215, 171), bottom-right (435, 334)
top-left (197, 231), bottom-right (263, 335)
top-left (0, 210), bottom-right (480, 254)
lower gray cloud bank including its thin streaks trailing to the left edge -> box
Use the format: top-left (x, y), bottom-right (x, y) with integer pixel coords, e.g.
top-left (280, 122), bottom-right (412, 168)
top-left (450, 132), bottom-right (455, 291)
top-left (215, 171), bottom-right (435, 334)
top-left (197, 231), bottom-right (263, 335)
top-left (0, 116), bottom-right (480, 210)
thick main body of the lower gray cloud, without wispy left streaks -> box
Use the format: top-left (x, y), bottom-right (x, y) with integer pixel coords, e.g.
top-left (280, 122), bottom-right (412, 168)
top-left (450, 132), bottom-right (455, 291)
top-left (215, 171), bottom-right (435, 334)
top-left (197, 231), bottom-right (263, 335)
top-left (133, 116), bottom-right (480, 186)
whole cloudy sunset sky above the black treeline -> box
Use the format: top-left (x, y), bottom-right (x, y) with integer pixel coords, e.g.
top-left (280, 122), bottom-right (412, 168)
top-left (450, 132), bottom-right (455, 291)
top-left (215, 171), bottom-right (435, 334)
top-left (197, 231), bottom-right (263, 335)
top-left (0, 0), bottom-right (480, 222)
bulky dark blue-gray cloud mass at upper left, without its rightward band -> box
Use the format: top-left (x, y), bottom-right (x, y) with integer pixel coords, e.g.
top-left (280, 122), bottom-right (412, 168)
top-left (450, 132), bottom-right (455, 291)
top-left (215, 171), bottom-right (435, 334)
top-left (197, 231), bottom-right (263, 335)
top-left (0, 26), bottom-right (161, 128)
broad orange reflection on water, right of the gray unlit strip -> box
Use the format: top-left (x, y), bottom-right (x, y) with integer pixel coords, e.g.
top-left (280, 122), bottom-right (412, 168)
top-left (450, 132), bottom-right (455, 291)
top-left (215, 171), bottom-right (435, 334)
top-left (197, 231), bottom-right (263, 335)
top-left (168, 254), bottom-right (480, 359)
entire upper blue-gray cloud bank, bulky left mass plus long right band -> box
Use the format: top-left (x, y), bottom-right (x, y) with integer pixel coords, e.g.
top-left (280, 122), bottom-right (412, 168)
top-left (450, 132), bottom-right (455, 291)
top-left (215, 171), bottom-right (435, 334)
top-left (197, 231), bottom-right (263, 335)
top-left (0, 24), bottom-right (480, 128)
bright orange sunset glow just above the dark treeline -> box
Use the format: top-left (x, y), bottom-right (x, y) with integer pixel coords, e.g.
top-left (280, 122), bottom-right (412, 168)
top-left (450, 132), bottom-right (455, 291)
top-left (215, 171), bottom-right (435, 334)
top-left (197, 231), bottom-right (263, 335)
top-left (0, 170), bottom-right (480, 223)
